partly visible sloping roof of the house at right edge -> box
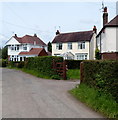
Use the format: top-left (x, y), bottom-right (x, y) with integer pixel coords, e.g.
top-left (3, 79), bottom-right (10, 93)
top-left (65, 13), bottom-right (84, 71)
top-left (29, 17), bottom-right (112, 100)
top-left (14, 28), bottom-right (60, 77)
top-left (96, 15), bottom-right (118, 37)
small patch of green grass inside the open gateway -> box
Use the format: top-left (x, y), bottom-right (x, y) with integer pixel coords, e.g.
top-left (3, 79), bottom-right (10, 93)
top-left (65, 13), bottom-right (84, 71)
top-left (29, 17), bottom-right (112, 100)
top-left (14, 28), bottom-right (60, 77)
top-left (67, 69), bottom-right (80, 79)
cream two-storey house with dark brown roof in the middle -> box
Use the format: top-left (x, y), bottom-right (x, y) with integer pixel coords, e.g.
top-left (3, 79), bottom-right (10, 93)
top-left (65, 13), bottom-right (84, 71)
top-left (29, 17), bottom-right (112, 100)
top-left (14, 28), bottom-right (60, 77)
top-left (52, 26), bottom-right (97, 60)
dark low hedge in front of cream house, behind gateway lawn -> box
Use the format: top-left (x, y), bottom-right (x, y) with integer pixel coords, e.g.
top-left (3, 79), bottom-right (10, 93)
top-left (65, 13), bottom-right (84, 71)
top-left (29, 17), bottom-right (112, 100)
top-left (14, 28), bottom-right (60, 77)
top-left (66, 60), bottom-right (82, 69)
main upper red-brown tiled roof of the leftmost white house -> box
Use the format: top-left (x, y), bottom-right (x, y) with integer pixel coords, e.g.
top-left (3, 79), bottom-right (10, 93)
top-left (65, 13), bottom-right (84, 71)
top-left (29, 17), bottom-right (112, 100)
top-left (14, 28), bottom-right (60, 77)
top-left (13, 35), bottom-right (46, 46)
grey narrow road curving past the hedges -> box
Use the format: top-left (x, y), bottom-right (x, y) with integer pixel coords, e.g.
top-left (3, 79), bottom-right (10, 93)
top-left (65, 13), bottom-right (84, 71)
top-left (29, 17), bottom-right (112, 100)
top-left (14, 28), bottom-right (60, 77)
top-left (2, 68), bottom-right (103, 118)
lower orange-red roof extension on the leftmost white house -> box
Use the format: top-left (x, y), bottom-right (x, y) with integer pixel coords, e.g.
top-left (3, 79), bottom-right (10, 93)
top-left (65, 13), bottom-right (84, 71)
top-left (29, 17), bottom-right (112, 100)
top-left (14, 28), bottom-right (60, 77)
top-left (19, 48), bottom-right (44, 55)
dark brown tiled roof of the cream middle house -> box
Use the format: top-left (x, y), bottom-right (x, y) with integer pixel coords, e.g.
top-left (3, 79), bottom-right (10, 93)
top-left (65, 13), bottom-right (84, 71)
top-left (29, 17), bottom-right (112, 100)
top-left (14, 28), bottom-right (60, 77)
top-left (52, 30), bottom-right (93, 43)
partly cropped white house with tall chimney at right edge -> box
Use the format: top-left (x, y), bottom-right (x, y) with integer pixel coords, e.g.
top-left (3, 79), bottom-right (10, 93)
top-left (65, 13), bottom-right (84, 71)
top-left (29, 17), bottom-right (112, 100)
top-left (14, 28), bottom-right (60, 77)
top-left (96, 7), bottom-right (118, 60)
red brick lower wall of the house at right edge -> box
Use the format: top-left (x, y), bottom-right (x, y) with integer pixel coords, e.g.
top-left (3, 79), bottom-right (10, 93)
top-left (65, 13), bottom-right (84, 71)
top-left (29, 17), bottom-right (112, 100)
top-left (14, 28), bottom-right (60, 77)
top-left (102, 52), bottom-right (118, 60)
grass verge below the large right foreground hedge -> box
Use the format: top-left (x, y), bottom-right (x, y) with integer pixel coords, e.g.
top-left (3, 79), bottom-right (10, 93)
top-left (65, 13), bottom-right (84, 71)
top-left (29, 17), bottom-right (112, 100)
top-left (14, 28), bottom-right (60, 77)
top-left (69, 84), bottom-right (118, 118)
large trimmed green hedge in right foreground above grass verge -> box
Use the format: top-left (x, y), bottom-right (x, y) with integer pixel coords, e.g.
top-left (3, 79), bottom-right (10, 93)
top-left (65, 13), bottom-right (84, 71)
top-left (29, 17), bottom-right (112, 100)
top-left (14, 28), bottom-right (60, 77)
top-left (82, 60), bottom-right (118, 102)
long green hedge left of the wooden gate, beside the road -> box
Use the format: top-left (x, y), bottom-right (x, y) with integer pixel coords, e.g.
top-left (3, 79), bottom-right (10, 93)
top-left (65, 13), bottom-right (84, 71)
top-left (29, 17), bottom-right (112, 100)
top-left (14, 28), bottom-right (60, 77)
top-left (25, 56), bottom-right (63, 79)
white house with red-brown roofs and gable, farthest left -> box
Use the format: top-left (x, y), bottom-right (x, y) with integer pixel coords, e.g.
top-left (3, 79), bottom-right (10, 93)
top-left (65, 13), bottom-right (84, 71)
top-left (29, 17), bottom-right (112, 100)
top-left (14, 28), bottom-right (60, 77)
top-left (6, 34), bottom-right (48, 61)
